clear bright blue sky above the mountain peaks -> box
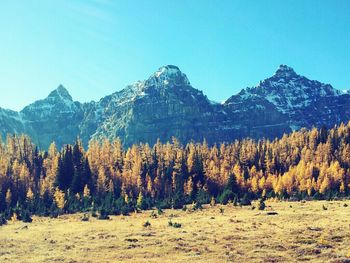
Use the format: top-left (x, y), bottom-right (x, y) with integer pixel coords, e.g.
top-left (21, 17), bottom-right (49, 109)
top-left (0, 0), bottom-right (350, 110)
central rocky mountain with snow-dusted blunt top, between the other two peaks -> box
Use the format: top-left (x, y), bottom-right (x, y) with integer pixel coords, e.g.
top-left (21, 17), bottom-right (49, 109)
top-left (89, 66), bottom-right (221, 144)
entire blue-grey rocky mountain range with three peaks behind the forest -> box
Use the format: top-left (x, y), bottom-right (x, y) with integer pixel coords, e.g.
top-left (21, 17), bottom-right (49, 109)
top-left (0, 65), bottom-right (350, 148)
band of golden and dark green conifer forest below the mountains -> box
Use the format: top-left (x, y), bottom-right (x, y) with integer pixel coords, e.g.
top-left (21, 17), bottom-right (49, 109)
top-left (0, 122), bottom-right (350, 225)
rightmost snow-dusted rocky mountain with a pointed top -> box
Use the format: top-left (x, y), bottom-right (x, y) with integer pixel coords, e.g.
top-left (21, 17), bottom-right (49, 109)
top-left (225, 65), bottom-right (350, 130)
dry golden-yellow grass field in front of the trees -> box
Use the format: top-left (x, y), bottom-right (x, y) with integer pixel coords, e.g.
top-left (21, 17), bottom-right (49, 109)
top-left (0, 201), bottom-right (350, 262)
